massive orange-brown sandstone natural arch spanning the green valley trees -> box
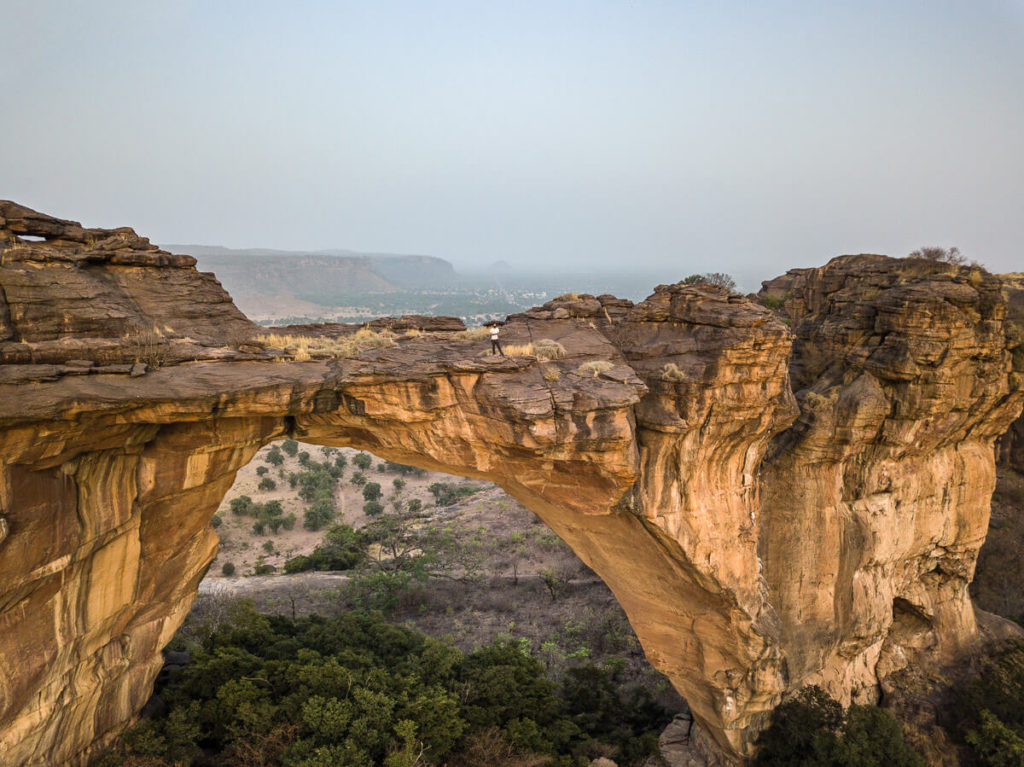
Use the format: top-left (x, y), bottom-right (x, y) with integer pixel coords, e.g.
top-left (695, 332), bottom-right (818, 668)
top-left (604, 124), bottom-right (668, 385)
top-left (0, 203), bottom-right (1024, 765)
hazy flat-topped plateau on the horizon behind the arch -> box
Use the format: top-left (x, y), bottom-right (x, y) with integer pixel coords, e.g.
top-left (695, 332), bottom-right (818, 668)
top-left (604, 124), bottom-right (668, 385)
top-left (161, 245), bottom-right (457, 296)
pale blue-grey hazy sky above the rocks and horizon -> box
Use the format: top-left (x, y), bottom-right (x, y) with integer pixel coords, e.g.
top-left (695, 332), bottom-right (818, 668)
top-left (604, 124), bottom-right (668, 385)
top-left (0, 0), bottom-right (1024, 276)
